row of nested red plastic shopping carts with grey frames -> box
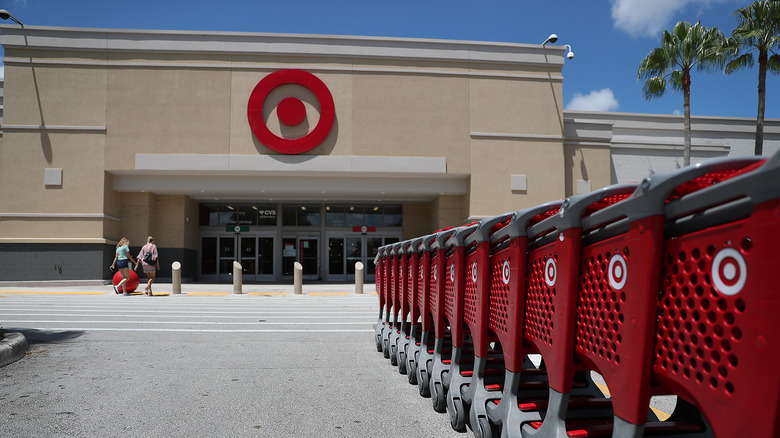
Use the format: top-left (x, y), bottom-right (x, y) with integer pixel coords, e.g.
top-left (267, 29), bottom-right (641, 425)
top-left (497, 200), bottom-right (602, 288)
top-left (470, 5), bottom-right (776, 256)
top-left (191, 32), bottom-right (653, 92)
top-left (375, 153), bottom-right (780, 437)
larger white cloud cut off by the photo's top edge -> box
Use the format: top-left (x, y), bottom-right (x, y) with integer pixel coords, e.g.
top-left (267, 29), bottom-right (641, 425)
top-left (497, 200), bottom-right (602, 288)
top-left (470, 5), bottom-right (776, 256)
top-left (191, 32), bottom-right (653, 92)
top-left (609, 0), bottom-right (731, 38)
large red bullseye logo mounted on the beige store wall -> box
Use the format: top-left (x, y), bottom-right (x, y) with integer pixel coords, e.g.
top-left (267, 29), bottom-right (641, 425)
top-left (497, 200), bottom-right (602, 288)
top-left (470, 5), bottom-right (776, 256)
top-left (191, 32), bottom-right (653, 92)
top-left (247, 70), bottom-right (336, 154)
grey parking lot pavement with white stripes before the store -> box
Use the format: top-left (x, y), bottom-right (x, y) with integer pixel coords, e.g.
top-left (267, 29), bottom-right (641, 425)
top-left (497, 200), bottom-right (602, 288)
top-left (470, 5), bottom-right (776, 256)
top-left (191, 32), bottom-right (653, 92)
top-left (0, 285), bottom-right (470, 437)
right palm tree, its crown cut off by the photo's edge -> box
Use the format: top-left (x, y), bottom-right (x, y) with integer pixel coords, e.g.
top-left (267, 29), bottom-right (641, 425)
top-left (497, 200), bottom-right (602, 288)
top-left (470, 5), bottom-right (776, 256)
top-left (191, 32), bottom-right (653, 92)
top-left (725, 0), bottom-right (780, 155)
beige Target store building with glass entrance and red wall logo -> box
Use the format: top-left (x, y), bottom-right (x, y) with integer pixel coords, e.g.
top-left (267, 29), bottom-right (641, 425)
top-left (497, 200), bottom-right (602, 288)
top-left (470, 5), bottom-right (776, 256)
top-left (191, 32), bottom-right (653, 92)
top-left (0, 24), bottom-right (777, 281)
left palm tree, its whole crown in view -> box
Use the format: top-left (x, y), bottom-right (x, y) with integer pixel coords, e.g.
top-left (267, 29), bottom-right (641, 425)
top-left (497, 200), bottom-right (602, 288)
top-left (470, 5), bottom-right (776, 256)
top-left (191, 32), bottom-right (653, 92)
top-left (637, 21), bottom-right (726, 166)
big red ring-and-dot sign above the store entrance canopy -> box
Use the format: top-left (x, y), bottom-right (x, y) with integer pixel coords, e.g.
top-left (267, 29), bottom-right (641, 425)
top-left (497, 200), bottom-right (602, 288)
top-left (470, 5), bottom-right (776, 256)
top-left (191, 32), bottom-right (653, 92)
top-left (247, 69), bottom-right (336, 154)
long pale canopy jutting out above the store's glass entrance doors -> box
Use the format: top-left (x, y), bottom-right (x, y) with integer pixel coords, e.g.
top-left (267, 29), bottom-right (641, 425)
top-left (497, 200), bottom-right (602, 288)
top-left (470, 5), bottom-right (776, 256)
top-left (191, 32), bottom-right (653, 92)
top-left (112, 154), bottom-right (467, 201)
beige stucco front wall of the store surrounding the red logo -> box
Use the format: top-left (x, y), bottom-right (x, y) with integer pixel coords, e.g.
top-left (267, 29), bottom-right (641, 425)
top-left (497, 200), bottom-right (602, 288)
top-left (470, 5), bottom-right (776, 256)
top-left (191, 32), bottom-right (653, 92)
top-left (0, 26), bottom-right (572, 249)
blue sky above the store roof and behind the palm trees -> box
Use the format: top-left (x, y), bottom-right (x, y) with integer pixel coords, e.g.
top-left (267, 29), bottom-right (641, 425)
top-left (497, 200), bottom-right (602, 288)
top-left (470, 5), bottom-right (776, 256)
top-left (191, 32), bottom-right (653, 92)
top-left (0, 0), bottom-right (780, 118)
